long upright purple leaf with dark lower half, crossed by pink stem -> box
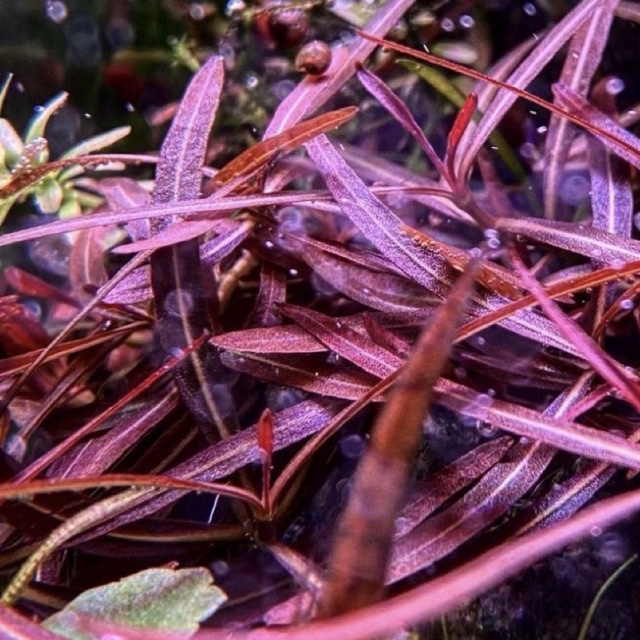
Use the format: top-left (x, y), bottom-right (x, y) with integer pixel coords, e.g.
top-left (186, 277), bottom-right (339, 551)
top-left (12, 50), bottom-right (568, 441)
top-left (151, 56), bottom-right (232, 440)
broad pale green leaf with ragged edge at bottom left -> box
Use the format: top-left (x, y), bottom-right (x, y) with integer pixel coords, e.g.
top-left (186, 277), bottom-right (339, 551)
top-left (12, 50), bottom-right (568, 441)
top-left (42, 567), bottom-right (227, 640)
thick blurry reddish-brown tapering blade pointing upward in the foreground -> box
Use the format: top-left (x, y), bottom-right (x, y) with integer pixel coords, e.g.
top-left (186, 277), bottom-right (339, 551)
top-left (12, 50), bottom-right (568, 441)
top-left (320, 260), bottom-right (478, 617)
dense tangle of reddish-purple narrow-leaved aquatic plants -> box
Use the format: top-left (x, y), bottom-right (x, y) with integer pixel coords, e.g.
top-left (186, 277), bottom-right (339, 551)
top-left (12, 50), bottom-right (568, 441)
top-left (0, 0), bottom-right (640, 638)
